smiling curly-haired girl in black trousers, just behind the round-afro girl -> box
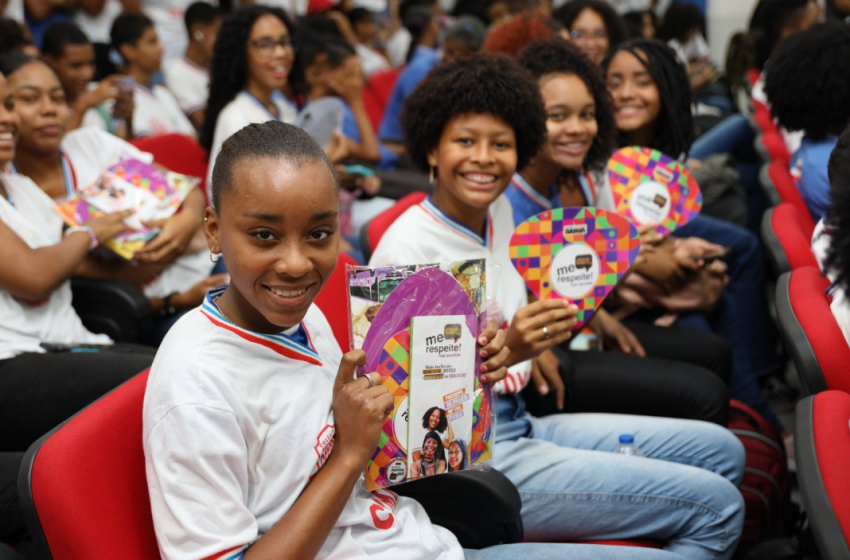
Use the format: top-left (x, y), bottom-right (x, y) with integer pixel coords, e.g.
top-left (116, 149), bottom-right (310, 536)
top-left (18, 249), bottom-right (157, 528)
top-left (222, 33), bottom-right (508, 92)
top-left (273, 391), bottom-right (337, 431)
top-left (505, 38), bottom-right (731, 425)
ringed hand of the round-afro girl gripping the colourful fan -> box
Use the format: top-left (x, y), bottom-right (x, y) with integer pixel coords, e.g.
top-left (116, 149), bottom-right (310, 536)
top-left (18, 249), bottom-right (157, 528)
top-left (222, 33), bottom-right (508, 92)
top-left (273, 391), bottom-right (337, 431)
top-left (505, 299), bottom-right (578, 367)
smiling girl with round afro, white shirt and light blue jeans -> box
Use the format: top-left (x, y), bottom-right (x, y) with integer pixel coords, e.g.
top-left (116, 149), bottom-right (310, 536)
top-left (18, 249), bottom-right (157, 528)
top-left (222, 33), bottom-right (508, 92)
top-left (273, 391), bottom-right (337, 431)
top-left (370, 54), bottom-right (744, 560)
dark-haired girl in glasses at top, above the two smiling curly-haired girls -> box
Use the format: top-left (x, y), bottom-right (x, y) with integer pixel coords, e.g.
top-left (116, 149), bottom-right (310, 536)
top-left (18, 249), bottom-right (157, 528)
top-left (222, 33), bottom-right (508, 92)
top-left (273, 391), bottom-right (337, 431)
top-left (553, 0), bottom-right (629, 64)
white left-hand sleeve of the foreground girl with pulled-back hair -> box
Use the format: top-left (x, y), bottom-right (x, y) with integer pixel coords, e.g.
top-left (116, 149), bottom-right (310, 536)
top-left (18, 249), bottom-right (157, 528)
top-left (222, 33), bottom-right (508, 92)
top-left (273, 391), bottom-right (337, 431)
top-left (144, 404), bottom-right (258, 560)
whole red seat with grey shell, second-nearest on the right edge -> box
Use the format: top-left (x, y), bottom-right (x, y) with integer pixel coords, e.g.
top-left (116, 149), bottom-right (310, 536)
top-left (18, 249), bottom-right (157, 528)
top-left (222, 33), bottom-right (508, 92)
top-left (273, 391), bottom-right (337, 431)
top-left (776, 267), bottom-right (850, 395)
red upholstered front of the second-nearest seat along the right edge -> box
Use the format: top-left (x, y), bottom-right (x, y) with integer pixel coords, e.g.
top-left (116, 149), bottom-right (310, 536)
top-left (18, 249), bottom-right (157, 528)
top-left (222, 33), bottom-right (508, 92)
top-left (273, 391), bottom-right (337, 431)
top-left (788, 267), bottom-right (850, 392)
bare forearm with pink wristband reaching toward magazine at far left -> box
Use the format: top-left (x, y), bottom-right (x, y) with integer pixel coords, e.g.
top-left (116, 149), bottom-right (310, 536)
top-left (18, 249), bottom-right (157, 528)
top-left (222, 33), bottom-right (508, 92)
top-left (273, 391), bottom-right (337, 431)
top-left (0, 211), bottom-right (133, 300)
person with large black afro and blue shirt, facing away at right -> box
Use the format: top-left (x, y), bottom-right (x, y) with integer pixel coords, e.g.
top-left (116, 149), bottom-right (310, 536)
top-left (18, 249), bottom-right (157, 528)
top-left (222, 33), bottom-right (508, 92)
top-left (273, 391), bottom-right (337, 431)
top-left (764, 22), bottom-right (850, 220)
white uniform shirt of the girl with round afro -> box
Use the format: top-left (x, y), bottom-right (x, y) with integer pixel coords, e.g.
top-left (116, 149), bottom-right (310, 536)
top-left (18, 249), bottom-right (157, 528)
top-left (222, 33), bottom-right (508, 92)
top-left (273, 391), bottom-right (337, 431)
top-left (369, 195), bottom-right (531, 393)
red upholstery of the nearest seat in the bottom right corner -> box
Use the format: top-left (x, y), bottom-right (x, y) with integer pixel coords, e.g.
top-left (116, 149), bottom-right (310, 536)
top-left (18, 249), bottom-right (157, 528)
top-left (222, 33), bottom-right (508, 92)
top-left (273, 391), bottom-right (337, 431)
top-left (810, 391), bottom-right (850, 546)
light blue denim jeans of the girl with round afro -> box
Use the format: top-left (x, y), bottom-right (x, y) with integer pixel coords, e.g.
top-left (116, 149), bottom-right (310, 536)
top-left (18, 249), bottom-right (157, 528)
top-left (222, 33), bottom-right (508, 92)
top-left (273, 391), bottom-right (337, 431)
top-left (493, 395), bottom-right (744, 560)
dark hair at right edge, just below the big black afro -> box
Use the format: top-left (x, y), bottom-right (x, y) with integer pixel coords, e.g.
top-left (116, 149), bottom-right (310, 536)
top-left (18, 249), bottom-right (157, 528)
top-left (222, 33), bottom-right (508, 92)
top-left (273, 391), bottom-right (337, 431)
top-left (826, 127), bottom-right (850, 291)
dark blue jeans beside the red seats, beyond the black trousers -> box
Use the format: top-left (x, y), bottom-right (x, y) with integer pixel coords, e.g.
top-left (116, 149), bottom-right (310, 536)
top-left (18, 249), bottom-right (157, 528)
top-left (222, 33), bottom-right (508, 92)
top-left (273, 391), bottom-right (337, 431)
top-left (675, 216), bottom-right (779, 426)
